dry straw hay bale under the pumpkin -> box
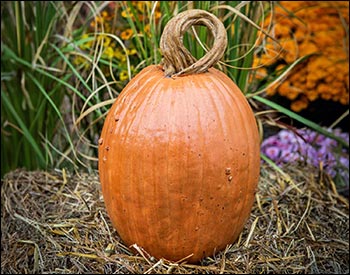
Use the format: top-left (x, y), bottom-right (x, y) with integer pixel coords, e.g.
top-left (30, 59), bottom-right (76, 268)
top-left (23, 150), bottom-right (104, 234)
top-left (1, 166), bottom-right (349, 274)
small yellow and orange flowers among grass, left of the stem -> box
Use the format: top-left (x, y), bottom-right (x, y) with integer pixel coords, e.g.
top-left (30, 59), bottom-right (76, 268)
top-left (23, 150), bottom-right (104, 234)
top-left (74, 1), bottom-right (161, 87)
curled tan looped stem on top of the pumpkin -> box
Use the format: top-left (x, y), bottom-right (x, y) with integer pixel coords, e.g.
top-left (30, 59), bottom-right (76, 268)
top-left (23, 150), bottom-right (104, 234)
top-left (160, 9), bottom-right (227, 77)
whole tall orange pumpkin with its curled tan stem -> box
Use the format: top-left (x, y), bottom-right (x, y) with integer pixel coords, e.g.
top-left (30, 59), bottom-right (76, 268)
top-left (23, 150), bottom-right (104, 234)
top-left (99, 10), bottom-right (260, 263)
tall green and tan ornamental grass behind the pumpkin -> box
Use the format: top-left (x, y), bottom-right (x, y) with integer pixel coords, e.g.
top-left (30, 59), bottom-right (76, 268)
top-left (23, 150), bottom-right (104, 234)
top-left (1, 1), bottom-right (349, 182)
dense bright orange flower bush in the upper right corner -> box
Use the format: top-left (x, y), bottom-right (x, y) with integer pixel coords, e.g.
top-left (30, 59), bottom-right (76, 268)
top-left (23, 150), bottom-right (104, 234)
top-left (254, 1), bottom-right (349, 112)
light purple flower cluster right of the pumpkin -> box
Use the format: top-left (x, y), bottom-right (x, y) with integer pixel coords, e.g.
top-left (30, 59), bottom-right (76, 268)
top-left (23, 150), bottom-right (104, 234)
top-left (261, 128), bottom-right (349, 185)
